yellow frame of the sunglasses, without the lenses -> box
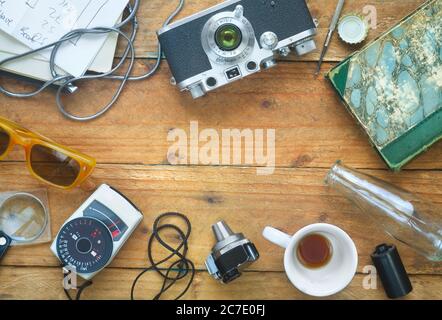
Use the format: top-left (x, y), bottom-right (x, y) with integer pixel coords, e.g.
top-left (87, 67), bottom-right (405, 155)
top-left (0, 117), bottom-right (96, 190)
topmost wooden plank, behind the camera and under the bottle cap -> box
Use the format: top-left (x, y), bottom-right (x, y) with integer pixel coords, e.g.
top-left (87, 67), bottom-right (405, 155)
top-left (119, 0), bottom-right (424, 61)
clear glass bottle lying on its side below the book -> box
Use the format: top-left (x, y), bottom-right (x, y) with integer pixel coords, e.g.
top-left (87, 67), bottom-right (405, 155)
top-left (325, 161), bottom-right (442, 261)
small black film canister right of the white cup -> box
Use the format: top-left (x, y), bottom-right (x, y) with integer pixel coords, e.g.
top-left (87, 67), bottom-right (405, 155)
top-left (371, 244), bottom-right (413, 299)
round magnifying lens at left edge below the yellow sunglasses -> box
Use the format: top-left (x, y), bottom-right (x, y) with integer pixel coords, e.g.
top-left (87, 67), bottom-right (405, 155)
top-left (0, 193), bottom-right (49, 259)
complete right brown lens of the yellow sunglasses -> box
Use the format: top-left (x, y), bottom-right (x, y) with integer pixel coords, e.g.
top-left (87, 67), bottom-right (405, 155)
top-left (31, 145), bottom-right (80, 187)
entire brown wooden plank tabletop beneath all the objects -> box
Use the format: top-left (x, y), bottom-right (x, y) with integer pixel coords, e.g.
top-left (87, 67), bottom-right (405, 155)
top-left (0, 0), bottom-right (442, 299)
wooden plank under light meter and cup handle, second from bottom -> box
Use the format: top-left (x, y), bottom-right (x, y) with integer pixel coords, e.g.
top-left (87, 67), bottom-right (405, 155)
top-left (0, 163), bottom-right (442, 274)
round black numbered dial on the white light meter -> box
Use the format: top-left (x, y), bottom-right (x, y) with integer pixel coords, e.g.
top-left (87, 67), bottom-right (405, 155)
top-left (57, 217), bottom-right (113, 273)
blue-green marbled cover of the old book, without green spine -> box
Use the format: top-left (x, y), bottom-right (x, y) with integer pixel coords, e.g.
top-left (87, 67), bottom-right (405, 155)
top-left (345, 0), bottom-right (442, 148)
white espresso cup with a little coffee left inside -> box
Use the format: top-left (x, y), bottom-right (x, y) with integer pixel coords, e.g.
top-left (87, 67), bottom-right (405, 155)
top-left (263, 223), bottom-right (358, 297)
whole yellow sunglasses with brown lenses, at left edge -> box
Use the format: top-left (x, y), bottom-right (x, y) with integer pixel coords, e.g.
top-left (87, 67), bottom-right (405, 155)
top-left (0, 117), bottom-right (96, 190)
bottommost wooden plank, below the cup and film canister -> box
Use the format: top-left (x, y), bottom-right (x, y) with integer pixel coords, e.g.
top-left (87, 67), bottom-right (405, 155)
top-left (0, 267), bottom-right (442, 300)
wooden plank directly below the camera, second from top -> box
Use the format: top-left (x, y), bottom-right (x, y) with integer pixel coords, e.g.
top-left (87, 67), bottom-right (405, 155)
top-left (0, 61), bottom-right (442, 169)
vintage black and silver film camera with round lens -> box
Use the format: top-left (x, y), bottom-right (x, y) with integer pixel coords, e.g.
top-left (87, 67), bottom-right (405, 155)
top-left (158, 0), bottom-right (316, 99)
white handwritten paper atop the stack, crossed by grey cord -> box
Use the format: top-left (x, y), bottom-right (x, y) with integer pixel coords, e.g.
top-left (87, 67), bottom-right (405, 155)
top-left (0, 0), bottom-right (129, 76)
